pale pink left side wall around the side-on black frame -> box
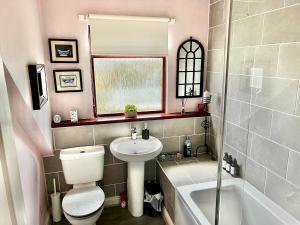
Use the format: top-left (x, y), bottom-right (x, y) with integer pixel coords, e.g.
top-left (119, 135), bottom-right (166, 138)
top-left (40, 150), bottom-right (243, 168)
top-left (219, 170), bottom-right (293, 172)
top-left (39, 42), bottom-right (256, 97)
top-left (0, 0), bottom-right (52, 225)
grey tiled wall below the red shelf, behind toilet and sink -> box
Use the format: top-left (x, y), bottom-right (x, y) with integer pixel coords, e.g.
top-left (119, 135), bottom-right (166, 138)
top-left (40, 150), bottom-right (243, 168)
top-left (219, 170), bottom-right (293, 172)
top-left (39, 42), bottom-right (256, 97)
top-left (44, 118), bottom-right (204, 200)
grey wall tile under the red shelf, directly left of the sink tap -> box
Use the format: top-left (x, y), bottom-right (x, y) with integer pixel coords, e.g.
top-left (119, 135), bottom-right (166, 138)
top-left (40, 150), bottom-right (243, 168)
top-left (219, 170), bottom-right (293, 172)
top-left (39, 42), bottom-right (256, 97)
top-left (94, 123), bottom-right (130, 145)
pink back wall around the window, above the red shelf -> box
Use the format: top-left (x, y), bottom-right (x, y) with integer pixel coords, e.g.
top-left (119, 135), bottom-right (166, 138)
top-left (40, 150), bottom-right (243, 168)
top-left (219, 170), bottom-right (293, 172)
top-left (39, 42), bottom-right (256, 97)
top-left (42, 0), bottom-right (209, 119)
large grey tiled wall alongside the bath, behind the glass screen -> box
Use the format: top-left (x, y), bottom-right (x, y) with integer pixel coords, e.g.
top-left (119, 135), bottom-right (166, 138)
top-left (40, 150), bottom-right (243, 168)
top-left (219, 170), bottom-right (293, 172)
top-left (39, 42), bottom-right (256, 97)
top-left (207, 0), bottom-right (300, 219)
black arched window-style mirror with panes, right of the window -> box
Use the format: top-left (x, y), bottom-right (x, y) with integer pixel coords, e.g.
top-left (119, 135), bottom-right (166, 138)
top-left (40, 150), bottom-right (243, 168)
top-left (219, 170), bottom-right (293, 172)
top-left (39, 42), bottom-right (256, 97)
top-left (176, 37), bottom-right (204, 98)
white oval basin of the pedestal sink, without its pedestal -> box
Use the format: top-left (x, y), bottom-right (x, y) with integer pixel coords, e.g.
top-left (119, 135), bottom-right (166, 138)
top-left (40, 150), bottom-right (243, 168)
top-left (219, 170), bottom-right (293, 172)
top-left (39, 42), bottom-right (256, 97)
top-left (110, 137), bottom-right (162, 162)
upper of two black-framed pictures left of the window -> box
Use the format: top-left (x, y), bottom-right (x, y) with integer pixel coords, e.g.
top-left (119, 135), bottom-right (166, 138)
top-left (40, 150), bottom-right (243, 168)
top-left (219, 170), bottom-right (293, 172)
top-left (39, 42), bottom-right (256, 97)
top-left (49, 39), bottom-right (79, 63)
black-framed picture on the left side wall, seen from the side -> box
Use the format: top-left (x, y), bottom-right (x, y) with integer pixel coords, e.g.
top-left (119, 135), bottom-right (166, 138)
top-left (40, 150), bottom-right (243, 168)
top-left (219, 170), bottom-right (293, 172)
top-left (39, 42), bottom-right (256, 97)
top-left (28, 64), bottom-right (48, 110)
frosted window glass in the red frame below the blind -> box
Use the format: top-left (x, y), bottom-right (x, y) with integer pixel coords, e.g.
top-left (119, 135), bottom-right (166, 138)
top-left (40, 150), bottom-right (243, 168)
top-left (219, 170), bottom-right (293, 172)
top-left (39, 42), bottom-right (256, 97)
top-left (93, 58), bottom-right (163, 114)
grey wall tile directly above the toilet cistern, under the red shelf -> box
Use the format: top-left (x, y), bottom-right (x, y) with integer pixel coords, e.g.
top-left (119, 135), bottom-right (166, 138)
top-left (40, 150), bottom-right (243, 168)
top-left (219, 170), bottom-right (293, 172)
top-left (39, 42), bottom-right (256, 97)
top-left (53, 126), bottom-right (94, 149)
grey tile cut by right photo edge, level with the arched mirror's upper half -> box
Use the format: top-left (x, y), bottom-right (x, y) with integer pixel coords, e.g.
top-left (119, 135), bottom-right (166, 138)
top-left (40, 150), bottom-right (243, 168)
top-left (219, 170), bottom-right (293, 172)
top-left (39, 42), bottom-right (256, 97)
top-left (278, 43), bottom-right (300, 78)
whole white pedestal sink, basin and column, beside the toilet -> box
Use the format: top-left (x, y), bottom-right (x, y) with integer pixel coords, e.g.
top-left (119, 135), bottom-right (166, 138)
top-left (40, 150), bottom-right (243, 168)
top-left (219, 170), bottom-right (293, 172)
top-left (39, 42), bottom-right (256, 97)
top-left (110, 136), bottom-right (162, 217)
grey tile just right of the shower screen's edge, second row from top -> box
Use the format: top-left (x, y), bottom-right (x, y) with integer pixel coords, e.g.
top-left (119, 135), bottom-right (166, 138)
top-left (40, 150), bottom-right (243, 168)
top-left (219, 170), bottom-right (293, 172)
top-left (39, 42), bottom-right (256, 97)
top-left (231, 15), bottom-right (263, 47)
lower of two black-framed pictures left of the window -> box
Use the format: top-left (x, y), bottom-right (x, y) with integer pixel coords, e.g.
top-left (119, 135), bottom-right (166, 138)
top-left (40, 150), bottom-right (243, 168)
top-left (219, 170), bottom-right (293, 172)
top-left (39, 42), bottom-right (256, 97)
top-left (53, 70), bottom-right (82, 92)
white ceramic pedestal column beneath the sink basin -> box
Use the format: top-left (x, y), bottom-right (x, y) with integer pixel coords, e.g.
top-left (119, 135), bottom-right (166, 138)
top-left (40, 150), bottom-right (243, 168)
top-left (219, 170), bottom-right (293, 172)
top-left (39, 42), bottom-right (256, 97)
top-left (127, 162), bottom-right (145, 217)
